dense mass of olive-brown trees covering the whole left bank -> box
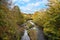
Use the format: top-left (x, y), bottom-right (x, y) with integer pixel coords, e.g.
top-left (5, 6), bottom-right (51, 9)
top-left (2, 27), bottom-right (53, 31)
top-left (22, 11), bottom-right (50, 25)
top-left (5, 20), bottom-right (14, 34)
top-left (0, 2), bottom-right (24, 40)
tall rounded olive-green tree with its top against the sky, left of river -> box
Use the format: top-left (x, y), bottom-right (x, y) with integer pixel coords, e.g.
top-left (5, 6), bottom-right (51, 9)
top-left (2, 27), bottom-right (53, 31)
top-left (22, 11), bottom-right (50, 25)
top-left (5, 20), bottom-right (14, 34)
top-left (12, 6), bottom-right (24, 25)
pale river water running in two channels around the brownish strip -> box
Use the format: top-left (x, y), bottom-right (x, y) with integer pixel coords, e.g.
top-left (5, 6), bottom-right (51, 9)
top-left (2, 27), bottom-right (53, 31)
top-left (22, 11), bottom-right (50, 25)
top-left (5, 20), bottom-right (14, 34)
top-left (21, 21), bottom-right (45, 40)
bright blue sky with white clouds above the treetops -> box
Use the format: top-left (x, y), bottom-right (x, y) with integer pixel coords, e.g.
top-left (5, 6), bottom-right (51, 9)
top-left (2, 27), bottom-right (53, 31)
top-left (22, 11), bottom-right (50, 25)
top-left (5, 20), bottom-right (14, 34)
top-left (12, 0), bottom-right (48, 13)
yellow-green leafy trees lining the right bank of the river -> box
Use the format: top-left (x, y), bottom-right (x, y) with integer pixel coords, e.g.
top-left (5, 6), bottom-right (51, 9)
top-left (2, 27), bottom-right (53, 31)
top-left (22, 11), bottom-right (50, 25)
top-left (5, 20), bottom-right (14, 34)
top-left (33, 0), bottom-right (60, 40)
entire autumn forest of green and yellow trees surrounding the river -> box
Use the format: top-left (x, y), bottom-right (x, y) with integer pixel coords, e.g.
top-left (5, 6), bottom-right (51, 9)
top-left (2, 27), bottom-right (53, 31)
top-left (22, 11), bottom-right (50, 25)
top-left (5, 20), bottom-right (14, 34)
top-left (0, 0), bottom-right (60, 40)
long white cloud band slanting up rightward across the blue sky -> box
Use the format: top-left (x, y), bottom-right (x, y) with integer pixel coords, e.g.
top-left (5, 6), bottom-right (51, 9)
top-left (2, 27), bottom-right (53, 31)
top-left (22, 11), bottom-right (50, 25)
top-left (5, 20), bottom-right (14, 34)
top-left (20, 0), bottom-right (48, 11)
